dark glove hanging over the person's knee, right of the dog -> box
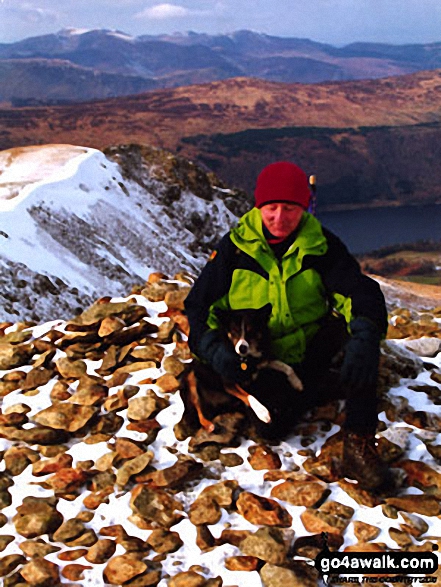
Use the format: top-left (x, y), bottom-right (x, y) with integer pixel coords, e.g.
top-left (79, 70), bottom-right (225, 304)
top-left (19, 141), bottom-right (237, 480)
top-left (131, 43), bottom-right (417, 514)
top-left (340, 317), bottom-right (381, 390)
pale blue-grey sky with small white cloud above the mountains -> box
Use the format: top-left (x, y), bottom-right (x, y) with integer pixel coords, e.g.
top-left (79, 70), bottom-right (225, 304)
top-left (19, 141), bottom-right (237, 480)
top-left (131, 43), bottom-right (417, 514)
top-left (0, 0), bottom-right (441, 45)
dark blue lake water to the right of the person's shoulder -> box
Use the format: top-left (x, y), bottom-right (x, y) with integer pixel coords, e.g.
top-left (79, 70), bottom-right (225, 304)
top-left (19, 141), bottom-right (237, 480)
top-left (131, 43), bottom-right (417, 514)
top-left (317, 204), bottom-right (441, 254)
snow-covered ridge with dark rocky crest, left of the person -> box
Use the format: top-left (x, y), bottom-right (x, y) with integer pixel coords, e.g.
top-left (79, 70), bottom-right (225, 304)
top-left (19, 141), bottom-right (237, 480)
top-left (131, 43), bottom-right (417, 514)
top-left (0, 145), bottom-right (248, 321)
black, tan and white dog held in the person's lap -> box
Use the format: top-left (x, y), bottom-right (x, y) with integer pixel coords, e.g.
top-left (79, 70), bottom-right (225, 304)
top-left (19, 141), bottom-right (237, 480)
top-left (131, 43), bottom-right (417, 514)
top-left (181, 304), bottom-right (303, 432)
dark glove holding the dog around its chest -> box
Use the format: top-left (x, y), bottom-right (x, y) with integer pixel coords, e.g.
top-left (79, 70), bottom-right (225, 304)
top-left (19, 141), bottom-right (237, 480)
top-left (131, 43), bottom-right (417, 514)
top-left (198, 330), bottom-right (257, 383)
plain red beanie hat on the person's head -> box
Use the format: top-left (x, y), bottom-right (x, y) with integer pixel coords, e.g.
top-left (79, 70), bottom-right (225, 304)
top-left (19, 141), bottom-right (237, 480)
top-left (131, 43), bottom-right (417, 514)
top-left (254, 161), bottom-right (311, 210)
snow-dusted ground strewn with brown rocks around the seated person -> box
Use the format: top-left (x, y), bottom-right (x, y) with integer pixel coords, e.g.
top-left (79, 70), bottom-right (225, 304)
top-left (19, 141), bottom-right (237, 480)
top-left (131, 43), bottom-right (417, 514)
top-left (0, 274), bottom-right (441, 587)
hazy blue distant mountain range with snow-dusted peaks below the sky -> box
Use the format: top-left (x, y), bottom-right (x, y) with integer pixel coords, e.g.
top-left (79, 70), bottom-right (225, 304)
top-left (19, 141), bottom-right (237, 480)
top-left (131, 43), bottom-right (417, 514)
top-left (0, 29), bottom-right (441, 106)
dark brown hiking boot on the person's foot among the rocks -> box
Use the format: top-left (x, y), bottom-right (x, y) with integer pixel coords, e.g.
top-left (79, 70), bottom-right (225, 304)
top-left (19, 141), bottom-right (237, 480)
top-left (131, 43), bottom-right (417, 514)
top-left (342, 432), bottom-right (392, 490)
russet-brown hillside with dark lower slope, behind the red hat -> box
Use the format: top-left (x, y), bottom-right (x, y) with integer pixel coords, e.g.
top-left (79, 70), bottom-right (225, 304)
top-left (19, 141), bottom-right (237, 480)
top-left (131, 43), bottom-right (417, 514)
top-left (0, 70), bottom-right (441, 209)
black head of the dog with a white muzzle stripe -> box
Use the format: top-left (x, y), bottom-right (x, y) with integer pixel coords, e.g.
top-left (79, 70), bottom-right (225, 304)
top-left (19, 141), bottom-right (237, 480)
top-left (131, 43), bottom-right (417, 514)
top-left (216, 304), bottom-right (272, 359)
